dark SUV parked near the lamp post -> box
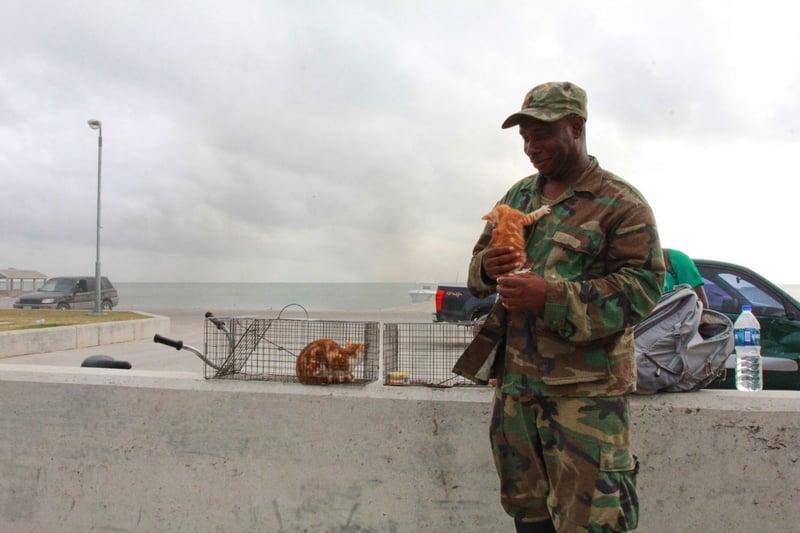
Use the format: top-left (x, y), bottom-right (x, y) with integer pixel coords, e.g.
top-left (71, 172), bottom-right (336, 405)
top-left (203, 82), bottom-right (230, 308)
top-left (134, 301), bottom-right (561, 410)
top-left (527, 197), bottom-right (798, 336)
top-left (14, 276), bottom-right (119, 311)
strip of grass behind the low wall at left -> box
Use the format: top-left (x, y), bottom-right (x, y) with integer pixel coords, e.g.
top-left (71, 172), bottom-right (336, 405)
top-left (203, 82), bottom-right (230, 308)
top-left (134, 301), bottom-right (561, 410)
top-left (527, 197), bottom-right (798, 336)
top-left (0, 309), bottom-right (150, 331)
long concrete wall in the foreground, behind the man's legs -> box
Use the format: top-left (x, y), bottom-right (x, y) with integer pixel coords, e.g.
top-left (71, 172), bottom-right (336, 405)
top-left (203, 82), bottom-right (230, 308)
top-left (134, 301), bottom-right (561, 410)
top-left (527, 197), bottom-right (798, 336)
top-left (0, 365), bottom-right (800, 532)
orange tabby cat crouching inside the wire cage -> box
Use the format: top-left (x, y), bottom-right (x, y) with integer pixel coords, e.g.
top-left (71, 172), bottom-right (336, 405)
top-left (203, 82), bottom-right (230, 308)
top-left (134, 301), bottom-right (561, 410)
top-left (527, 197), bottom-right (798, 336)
top-left (295, 339), bottom-right (364, 385)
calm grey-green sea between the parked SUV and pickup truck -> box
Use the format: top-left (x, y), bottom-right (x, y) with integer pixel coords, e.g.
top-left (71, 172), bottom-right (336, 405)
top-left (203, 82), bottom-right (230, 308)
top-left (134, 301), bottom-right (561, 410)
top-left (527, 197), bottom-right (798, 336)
top-left (114, 282), bottom-right (428, 311)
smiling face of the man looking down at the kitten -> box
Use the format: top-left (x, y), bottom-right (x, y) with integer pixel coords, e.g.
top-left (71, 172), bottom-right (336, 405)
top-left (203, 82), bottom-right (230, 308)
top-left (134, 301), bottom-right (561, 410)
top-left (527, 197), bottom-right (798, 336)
top-left (519, 117), bottom-right (578, 179)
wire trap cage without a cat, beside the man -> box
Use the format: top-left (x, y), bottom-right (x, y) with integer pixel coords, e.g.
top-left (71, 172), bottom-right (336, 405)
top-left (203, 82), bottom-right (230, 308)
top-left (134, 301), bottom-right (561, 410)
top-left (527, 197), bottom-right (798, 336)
top-left (383, 322), bottom-right (479, 387)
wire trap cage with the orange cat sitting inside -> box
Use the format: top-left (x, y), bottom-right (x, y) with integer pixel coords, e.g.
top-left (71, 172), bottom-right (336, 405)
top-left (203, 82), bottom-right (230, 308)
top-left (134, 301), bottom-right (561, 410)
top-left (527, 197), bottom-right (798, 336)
top-left (204, 317), bottom-right (380, 383)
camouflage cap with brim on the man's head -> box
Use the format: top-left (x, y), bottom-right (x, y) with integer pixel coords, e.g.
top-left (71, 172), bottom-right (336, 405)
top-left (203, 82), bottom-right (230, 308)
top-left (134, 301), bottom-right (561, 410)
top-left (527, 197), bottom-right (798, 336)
top-left (502, 81), bottom-right (587, 128)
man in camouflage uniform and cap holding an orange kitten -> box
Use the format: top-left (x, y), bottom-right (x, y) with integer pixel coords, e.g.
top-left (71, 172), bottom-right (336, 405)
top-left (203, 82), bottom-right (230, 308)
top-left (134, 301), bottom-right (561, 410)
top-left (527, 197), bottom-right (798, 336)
top-left (453, 82), bottom-right (664, 532)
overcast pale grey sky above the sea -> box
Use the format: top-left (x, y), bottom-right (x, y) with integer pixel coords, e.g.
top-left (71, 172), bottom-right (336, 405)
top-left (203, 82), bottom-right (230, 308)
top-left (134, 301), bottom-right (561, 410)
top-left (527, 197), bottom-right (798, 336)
top-left (0, 0), bottom-right (800, 284)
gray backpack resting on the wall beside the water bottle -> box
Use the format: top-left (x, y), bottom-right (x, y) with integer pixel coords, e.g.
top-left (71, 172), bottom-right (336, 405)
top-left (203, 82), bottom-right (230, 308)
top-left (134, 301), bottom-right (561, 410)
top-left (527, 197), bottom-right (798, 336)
top-left (633, 284), bottom-right (733, 394)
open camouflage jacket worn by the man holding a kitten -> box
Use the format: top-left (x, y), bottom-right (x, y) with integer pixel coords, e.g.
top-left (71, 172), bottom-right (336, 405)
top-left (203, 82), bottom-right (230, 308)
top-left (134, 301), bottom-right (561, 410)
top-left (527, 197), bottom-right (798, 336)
top-left (453, 158), bottom-right (664, 396)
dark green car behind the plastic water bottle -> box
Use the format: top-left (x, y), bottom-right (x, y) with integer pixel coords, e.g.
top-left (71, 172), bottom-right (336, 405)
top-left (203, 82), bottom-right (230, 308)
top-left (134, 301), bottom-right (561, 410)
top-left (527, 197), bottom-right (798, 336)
top-left (694, 259), bottom-right (800, 390)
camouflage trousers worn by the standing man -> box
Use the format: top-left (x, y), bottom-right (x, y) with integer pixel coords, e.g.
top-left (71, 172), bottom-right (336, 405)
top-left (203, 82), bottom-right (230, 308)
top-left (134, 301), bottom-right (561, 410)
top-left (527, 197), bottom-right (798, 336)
top-left (490, 389), bottom-right (639, 532)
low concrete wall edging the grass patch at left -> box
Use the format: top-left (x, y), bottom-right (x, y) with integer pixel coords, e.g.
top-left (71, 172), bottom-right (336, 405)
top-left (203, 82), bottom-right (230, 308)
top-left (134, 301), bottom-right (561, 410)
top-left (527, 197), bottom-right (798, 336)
top-left (0, 313), bottom-right (170, 357)
